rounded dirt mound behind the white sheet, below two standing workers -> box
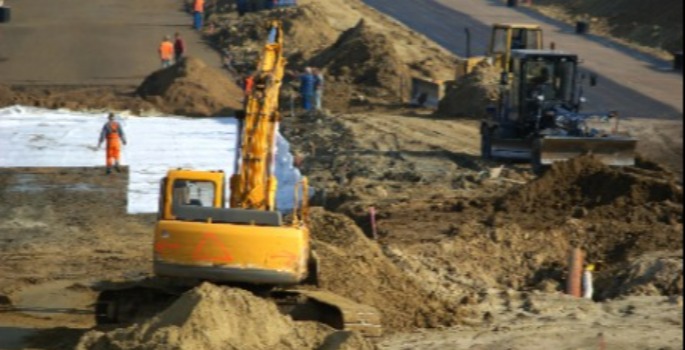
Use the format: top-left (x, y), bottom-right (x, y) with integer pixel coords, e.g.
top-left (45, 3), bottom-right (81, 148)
top-left (136, 57), bottom-right (242, 117)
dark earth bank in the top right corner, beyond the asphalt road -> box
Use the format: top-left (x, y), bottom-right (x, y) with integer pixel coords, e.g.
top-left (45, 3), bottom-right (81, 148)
top-left (535, 0), bottom-right (683, 52)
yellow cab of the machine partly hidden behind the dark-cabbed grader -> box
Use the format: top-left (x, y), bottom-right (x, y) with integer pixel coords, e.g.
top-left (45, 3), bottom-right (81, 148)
top-left (487, 23), bottom-right (542, 72)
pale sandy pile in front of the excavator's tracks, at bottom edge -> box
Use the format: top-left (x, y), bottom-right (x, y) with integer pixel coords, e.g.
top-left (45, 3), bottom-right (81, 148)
top-left (77, 283), bottom-right (369, 350)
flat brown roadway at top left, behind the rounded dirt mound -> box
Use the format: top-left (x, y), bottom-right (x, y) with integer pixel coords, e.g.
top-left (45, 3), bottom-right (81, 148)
top-left (0, 0), bottom-right (221, 85)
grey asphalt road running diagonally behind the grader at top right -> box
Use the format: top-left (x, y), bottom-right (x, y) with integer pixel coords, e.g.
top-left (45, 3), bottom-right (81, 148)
top-left (364, 0), bottom-right (683, 119)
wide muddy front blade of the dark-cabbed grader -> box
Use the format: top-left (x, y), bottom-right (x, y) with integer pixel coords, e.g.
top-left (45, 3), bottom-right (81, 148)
top-left (535, 136), bottom-right (637, 166)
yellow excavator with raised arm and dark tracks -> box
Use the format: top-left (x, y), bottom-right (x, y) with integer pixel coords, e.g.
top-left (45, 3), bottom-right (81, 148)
top-left (95, 21), bottom-right (382, 336)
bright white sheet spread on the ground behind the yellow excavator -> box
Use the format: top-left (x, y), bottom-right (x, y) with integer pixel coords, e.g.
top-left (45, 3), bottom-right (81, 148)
top-left (0, 106), bottom-right (301, 214)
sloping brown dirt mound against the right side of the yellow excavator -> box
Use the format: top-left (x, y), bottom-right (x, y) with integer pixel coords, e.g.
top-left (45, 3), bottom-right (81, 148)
top-left (311, 209), bottom-right (461, 332)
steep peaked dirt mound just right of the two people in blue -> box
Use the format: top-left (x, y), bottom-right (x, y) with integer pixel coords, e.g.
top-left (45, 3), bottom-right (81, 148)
top-left (309, 19), bottom-right (409, 103)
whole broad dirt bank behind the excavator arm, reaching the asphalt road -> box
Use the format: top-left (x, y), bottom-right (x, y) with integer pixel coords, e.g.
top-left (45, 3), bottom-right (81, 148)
top-left (210, 0), bottom-right (456, 110)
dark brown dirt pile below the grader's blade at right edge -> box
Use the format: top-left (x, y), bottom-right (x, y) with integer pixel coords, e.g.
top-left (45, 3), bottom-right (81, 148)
top-left (487, 156), bottom-right (683, 279)
